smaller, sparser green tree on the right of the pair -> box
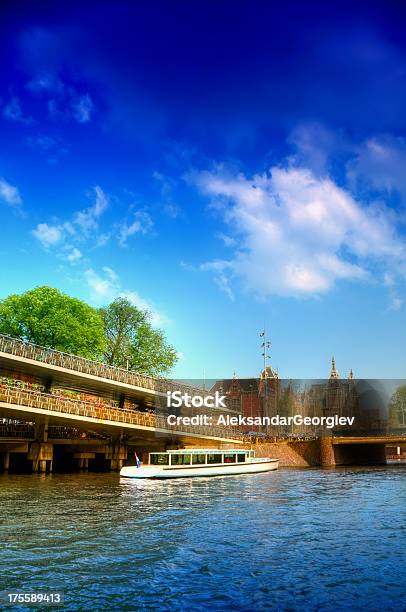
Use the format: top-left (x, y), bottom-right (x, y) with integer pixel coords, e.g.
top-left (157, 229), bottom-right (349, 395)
top-left (100, 298), bottom-right (178, 376)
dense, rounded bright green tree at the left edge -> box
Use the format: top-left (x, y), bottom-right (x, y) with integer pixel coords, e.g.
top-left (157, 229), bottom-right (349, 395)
top-left (0, 286), bottom-right (106, 359)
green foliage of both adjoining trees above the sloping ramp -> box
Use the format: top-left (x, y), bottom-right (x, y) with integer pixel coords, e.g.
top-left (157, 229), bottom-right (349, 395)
top-left (0, 286), bottom-right (178, 375)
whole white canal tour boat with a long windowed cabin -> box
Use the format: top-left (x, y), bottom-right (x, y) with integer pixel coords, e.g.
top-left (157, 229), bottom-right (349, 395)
top-left (120, 448), bottom-right (279, 478)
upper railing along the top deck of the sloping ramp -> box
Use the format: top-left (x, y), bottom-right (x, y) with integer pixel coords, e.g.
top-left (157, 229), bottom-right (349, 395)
top-left (0, 334), bottom-right (204, 395)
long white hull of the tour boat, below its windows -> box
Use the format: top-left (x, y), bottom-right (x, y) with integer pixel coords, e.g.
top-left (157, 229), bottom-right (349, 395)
top-left (120, 459), bottom-right (279, 479)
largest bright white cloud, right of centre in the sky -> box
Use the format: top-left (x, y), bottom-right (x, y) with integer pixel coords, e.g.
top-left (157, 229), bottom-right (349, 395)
top-left (194, 167), bottom-right (406, 297)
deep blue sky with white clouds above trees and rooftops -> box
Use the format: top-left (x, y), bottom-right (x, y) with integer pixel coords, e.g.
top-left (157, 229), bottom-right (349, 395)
top-left (0, 0), bottom-right (406, 378)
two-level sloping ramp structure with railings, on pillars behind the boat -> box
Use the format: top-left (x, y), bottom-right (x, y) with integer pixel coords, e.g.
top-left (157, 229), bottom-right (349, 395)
top-left (0, 335), bottom-right (243, 471)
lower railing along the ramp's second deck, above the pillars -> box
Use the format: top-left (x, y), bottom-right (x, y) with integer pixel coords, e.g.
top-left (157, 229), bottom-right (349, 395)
top-left (0, 386), bottom-right (238, 438)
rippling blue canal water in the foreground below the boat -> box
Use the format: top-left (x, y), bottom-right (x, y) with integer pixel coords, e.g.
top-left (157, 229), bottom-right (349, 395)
top-left (0, 465), bottom-right (406, 611)
